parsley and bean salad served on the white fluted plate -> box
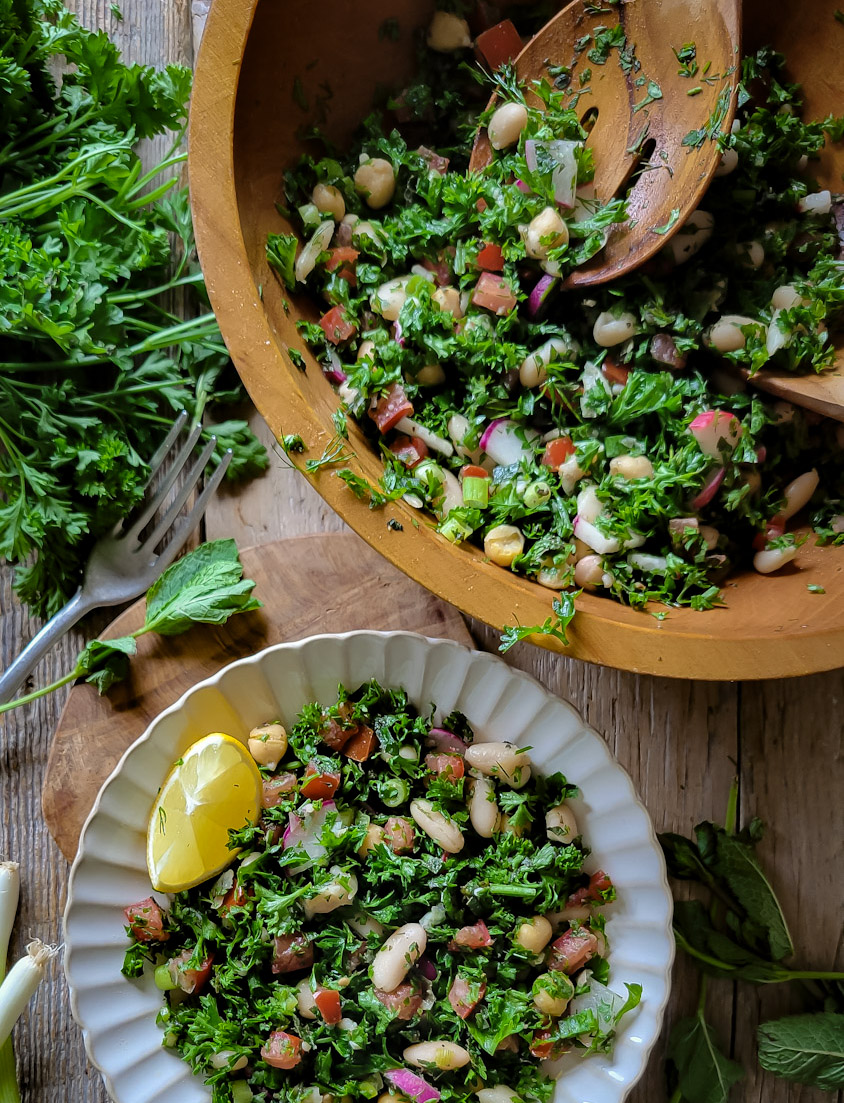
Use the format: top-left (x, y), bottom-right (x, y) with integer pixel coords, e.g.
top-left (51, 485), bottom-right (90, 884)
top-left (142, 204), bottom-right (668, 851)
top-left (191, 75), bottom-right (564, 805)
top-left (124, 682), bottom-right (641, 1103)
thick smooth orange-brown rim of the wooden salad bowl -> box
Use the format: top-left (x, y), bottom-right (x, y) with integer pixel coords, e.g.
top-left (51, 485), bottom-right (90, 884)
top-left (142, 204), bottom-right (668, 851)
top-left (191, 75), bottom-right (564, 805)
top-left (189, 0), bottom-right (844, 681)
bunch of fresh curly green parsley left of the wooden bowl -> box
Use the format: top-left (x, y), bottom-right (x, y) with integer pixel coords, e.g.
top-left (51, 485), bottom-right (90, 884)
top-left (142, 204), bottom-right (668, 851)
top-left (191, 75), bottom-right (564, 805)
top-left (0, 0), bottom-right (266, 614)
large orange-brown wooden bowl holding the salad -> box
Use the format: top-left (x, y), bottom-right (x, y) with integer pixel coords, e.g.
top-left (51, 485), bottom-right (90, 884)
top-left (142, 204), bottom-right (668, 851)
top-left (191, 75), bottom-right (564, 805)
top-left (190, 0), bottom-right (844, 679)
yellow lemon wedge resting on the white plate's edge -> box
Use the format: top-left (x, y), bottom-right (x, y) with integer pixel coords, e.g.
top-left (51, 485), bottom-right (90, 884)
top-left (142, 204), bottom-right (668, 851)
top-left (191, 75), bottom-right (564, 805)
top-left (147, 731), bottom-right (261, 892)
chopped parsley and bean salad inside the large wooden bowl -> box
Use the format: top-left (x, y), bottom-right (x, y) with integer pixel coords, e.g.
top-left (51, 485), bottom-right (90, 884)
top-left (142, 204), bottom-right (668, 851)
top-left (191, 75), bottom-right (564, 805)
top-left (267, 6), bottom-right (844, 630)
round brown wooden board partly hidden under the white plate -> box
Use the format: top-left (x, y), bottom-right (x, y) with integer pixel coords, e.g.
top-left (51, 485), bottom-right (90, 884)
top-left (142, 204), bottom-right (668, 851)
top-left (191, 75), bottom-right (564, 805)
top-left (41, 533), bottom-right (472, 860)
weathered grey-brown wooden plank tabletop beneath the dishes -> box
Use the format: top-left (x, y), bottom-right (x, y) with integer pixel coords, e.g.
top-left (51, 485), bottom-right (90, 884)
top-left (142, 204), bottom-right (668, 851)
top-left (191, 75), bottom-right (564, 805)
top-left (0, 0), bottom-right (844, 1103)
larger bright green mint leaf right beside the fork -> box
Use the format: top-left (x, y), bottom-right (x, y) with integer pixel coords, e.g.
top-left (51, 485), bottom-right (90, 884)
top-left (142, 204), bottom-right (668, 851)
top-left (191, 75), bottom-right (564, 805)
top-left (143, 540), bottom-right (261, 635)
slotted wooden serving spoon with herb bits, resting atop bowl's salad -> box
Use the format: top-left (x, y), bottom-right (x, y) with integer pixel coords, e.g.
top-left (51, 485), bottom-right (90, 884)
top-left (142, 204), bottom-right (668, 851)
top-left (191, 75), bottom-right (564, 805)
top-left (469, 0), bottom-right (740, 288)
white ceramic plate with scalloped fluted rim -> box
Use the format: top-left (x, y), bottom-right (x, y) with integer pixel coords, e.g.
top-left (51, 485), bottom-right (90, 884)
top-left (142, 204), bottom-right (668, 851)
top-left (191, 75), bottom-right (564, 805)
top-left (64, 632), bottom-right (674, 1103)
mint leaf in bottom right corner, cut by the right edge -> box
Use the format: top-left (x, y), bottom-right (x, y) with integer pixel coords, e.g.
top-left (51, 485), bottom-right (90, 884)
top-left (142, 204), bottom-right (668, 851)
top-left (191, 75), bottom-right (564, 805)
top-left (757, 1011), bottom-right (844, 1092)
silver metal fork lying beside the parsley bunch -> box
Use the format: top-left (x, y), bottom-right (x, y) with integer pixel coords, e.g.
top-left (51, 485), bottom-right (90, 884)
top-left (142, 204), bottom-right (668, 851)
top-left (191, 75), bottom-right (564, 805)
top-left (0, 410), bottom-right (232, 705)
